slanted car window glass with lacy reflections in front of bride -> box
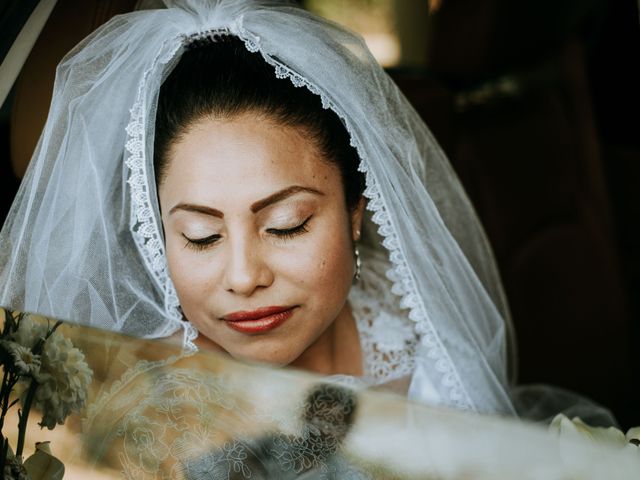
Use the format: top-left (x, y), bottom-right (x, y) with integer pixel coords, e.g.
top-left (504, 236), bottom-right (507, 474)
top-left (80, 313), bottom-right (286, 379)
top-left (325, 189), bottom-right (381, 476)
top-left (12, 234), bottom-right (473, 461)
top-left (6, 309), bottom-right (640, 480)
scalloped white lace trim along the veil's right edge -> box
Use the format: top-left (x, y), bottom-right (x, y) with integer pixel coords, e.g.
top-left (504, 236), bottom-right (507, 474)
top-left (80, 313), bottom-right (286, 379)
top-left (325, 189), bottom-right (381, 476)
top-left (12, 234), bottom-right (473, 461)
top-left (230, 17), bottom-right (475, 410)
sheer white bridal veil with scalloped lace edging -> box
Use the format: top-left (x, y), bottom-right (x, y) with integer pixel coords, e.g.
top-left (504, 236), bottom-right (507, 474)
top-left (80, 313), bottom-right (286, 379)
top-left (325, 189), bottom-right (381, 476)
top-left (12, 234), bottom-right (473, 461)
top-left (0, 0), bottom-right (514, 413)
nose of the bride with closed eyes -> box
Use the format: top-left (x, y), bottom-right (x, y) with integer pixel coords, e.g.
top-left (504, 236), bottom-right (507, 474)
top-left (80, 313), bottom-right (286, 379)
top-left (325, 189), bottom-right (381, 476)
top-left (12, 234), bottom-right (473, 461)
top-left (223, 234), bottom-right (273, 296)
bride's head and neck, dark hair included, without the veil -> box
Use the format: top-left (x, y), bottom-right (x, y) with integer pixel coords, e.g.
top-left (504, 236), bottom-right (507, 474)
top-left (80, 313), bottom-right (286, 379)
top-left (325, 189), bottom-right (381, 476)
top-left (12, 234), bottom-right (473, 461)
top-left (154, 35), bottom-right (364, 375)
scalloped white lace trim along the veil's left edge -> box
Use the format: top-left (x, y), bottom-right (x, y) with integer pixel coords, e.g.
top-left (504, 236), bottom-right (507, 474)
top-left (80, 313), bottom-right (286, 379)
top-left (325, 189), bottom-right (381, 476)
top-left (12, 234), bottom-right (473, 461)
top-left (125, 39), bottom-right (198, 351)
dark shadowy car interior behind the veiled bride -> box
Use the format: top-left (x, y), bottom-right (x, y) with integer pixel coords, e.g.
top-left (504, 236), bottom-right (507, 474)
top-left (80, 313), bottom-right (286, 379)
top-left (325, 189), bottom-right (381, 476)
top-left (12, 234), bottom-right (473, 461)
top-left (0, 0), bottom-right (640, 428)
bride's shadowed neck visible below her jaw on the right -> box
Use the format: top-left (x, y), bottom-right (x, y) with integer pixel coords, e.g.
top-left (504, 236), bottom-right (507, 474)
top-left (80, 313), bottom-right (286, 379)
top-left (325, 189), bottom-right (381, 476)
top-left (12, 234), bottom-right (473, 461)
top-left (291, 302), bottom-right (363, 376)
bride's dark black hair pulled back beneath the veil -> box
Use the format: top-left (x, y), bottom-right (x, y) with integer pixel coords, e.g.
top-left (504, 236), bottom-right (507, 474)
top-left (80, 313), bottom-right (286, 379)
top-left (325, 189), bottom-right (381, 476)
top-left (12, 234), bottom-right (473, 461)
top-left (154, 35), bottom-right (364, 209)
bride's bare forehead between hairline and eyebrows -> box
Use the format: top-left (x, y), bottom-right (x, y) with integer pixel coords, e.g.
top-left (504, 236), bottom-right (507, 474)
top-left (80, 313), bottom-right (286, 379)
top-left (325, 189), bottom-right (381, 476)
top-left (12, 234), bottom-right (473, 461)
top-left (160, 113), bottom-right (341, 201)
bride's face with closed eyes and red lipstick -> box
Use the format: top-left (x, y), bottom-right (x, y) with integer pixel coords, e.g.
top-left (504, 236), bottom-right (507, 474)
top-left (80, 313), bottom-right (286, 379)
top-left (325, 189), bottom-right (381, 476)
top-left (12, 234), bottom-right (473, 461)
top-left (159, 113), bottom-right (362, 365)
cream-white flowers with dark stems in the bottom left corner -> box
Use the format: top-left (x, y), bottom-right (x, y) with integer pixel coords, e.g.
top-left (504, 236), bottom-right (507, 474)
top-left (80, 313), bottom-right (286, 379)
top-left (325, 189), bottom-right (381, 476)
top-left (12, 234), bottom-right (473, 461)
top-left (0, 310), bottom-right (93, 480)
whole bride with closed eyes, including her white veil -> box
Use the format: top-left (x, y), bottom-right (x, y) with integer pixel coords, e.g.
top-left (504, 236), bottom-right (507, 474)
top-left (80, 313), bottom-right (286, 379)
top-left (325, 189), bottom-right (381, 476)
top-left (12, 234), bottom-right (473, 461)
top-left (0, 1), bottom-right (514, 414)
